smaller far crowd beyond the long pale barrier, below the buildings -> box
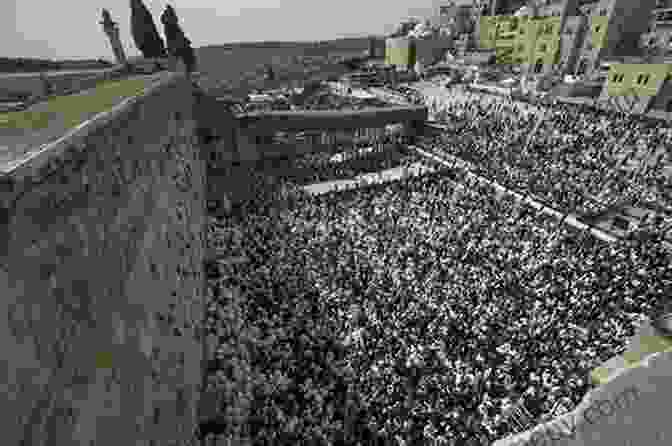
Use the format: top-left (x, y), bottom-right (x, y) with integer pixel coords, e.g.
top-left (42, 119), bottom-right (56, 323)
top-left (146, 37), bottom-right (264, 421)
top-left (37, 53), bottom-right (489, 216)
top-left (426, 87), bottom-right (672, 221)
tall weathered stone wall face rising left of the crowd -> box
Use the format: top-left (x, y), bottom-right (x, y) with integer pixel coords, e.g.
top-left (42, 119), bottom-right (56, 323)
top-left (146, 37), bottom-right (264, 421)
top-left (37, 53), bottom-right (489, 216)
top-left (0, 71), bottom-right (206, 446)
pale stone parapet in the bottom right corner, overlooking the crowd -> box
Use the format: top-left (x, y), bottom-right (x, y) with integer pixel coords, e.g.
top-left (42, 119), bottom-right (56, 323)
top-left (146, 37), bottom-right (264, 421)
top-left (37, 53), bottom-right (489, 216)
top-left (493, 323), bottom-right (672, 446)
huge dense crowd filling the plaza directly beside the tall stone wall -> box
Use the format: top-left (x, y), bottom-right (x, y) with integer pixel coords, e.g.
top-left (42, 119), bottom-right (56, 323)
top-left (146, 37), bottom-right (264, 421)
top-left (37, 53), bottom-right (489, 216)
top-left (205, 161), bottom-right (672, 445)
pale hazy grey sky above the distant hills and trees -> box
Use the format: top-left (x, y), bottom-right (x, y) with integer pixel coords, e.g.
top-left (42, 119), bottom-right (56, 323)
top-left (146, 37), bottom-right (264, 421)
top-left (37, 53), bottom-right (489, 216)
top-left (0, 0), bottom-right (454, 59)
